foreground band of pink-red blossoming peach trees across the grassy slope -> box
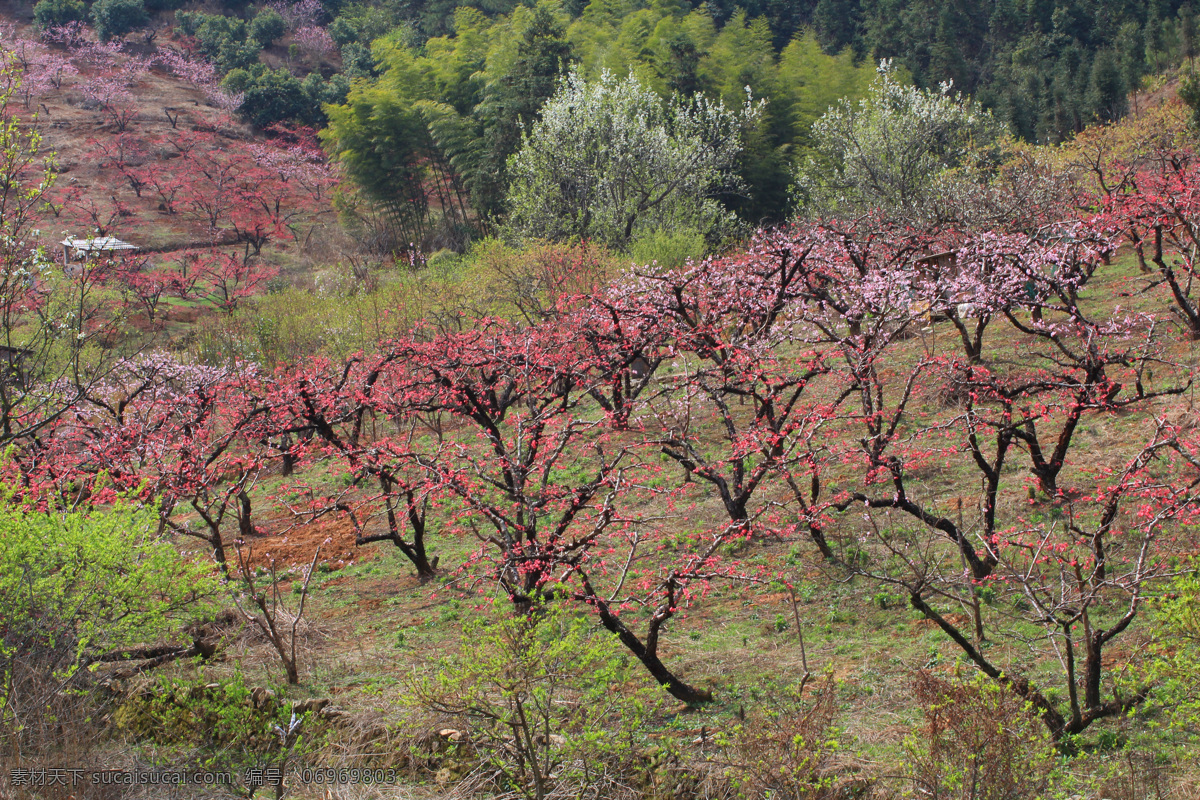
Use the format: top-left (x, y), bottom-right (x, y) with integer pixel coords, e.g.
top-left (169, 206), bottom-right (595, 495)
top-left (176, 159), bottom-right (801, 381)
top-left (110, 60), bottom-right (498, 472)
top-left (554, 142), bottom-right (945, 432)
top-left (13, 189), bottom-right (1200, 735)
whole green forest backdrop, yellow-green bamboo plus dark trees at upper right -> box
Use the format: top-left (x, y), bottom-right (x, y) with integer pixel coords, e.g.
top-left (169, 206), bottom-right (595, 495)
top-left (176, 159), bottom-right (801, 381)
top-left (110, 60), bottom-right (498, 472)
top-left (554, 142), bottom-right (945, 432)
top-left (309, 0), bottom-right (1194, 243)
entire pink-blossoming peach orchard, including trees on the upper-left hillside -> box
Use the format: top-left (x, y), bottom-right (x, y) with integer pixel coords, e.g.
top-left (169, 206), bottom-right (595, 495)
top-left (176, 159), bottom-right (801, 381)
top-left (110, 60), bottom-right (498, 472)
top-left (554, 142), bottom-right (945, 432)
top-left (7, 28), bottom-right (1200, 739)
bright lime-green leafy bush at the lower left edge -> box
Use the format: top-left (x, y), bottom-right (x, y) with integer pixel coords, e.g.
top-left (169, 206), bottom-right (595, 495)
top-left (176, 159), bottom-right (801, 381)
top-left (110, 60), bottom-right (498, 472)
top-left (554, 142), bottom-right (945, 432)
top-left (0, 498), bottom-right (216, 762)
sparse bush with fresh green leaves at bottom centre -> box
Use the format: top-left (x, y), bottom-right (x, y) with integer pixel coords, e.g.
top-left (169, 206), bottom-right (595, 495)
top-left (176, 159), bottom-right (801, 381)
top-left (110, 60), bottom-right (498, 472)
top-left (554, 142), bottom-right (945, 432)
top-left (409, 609), bottom-right (658, 798)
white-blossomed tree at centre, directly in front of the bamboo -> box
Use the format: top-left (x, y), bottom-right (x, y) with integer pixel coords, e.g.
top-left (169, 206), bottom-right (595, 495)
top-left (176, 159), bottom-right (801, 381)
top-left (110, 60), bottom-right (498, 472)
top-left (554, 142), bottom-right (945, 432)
top-left (509, 71), bottom-right (761, 247)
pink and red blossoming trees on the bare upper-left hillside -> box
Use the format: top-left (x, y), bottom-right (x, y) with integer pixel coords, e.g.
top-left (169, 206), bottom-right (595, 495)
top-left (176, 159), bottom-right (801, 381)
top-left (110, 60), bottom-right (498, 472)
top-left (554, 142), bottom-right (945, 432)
top-left (0, 24), bottom-right (332, 254)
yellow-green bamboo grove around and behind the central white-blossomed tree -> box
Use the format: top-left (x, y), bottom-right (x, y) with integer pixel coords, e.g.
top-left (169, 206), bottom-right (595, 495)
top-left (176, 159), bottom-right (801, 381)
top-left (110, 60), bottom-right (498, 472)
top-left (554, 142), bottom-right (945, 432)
top-left (321, 0), bottom-right (892, 235)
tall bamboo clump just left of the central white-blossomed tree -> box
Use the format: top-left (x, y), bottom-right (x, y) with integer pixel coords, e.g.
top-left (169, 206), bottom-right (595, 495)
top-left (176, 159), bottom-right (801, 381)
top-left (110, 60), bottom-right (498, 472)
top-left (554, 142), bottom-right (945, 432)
top-left (324, 2), bottom-right (571, 248)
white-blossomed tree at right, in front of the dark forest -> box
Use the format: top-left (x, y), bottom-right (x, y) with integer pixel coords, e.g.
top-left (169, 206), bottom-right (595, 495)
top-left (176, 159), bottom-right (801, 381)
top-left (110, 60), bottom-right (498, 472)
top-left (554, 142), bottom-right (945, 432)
top-left (794, 60), bottom-right (1007, 221)
